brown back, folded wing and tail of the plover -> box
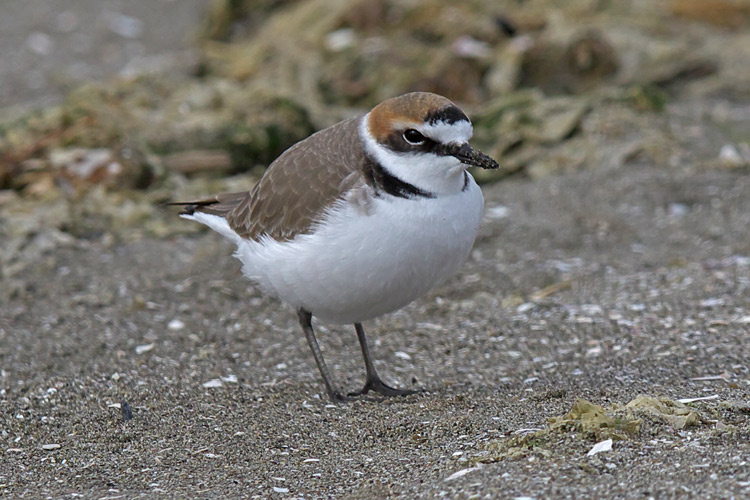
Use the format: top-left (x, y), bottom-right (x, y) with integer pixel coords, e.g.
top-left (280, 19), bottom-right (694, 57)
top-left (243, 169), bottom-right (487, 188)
top-left (184, 118), bottom-right (364, 241)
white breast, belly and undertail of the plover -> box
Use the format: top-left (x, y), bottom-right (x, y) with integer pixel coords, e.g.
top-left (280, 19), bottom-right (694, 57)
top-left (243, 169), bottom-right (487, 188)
top-left (194, 179), bottom-right (484, 323)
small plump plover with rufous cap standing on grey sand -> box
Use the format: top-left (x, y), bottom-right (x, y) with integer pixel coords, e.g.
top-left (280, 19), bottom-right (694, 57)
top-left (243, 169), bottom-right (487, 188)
top-left (175, 92), bottom-right (498, 401)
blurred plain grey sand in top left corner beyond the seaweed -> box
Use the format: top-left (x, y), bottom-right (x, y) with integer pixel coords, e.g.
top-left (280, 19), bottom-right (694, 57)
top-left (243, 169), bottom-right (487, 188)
top-left (0, 0), bottom-right (208, 108)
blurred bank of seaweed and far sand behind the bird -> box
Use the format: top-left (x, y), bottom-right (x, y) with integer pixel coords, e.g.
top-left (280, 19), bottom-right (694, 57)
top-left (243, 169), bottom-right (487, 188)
top-left (0, 0), bottom-right (750, 277)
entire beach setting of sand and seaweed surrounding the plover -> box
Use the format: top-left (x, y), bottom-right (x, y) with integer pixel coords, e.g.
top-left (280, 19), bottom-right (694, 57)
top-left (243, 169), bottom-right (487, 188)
top-left (0, 0), bottom-right (750, 499)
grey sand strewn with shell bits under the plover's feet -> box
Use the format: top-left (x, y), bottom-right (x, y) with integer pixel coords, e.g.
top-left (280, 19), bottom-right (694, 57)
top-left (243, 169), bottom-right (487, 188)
top-left (0, 0), bottom-right (750, 499)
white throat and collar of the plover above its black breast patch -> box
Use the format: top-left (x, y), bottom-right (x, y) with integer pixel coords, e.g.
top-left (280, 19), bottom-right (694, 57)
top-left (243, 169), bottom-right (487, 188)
top-left (359, 114), bottom-right (466, 195)
